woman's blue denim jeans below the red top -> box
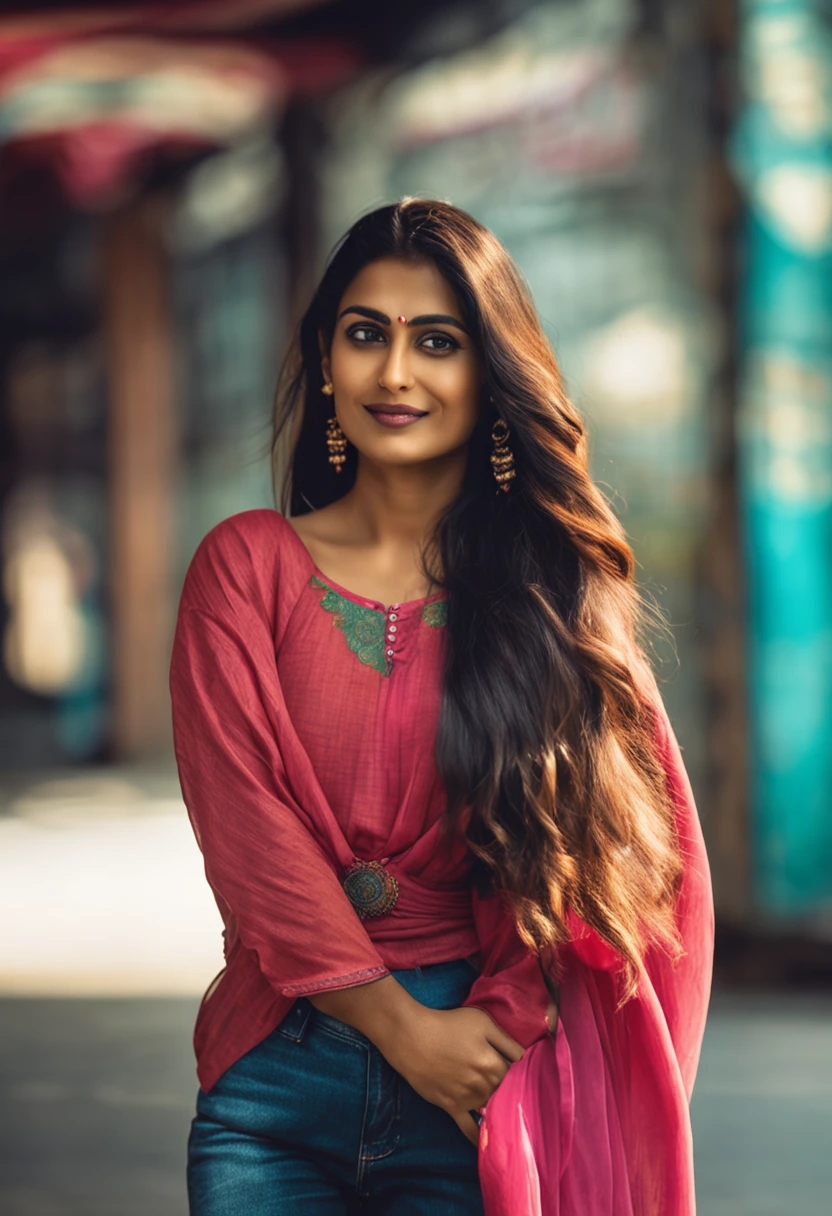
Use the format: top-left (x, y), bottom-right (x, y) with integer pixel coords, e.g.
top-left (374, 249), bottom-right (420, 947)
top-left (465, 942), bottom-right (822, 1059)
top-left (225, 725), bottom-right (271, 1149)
top-left (187, 958), bottom-right (483, 1216)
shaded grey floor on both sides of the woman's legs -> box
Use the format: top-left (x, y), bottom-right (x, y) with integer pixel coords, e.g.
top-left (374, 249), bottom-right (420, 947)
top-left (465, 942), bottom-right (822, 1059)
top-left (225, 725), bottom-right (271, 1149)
top-left (0, 993), bottom-right (832, 1216)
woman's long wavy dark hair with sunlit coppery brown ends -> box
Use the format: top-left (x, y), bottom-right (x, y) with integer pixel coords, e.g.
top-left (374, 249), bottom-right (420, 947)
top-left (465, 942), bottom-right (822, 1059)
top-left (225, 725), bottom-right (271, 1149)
top-left (272, 198), bottom-right (681, 1001)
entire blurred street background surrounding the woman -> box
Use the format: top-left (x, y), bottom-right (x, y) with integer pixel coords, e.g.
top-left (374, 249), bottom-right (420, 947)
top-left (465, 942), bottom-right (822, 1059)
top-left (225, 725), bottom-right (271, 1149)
top-left (0, 0), bottom-right (832, 1216)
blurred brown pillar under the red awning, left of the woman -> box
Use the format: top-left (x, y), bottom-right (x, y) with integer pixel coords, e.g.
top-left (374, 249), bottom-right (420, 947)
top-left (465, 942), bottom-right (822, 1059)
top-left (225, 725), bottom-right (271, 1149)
top-left (103, 199), bottom-right (175, 759)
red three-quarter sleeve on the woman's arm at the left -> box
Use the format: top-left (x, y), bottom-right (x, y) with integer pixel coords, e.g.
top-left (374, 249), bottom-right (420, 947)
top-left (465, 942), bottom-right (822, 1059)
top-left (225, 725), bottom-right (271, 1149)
top-left (170, 534), bottom-right (388, 996)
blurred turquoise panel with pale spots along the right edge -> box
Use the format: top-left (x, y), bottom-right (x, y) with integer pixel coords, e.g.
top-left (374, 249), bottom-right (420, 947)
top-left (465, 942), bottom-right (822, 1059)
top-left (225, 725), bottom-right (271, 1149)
top-left (735, 0), bottom-right (832, 921)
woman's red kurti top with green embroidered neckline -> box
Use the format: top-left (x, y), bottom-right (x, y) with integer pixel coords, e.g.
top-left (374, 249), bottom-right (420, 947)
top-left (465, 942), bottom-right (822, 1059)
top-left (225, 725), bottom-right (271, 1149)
top-left (170, 510), bottom-right (550, 1090)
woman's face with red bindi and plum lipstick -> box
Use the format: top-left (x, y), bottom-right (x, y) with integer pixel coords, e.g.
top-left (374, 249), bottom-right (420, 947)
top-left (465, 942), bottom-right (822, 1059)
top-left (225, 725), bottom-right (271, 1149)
top-left (322, 258), bottom-right (480, 465)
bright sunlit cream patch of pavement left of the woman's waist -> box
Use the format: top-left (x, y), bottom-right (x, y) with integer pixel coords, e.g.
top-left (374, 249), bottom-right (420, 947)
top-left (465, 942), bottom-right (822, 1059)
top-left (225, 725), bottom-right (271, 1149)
top-left (0, 769), bottom-right (223, 997)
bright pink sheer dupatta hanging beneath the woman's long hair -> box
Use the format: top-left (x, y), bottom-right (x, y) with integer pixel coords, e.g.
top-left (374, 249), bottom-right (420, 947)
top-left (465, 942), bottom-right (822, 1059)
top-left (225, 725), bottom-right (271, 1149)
top-left (478, 705), bottom-right (714, 1216)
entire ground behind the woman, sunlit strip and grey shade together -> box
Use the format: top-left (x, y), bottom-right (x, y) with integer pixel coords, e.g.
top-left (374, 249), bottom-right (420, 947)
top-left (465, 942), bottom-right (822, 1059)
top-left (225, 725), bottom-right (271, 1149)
top-left (0, 770), bottom-right (832, 1216)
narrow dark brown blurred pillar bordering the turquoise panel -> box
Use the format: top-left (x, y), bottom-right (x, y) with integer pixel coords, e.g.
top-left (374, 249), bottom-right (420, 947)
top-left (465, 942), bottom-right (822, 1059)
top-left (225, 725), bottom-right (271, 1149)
top-left (698, 0), bottom-right (753, 925)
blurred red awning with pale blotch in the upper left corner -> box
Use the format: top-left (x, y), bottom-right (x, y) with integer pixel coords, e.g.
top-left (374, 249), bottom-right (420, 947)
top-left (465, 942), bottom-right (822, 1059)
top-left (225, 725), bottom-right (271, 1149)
top-left (0, 0), bottom-right (360, 206)
